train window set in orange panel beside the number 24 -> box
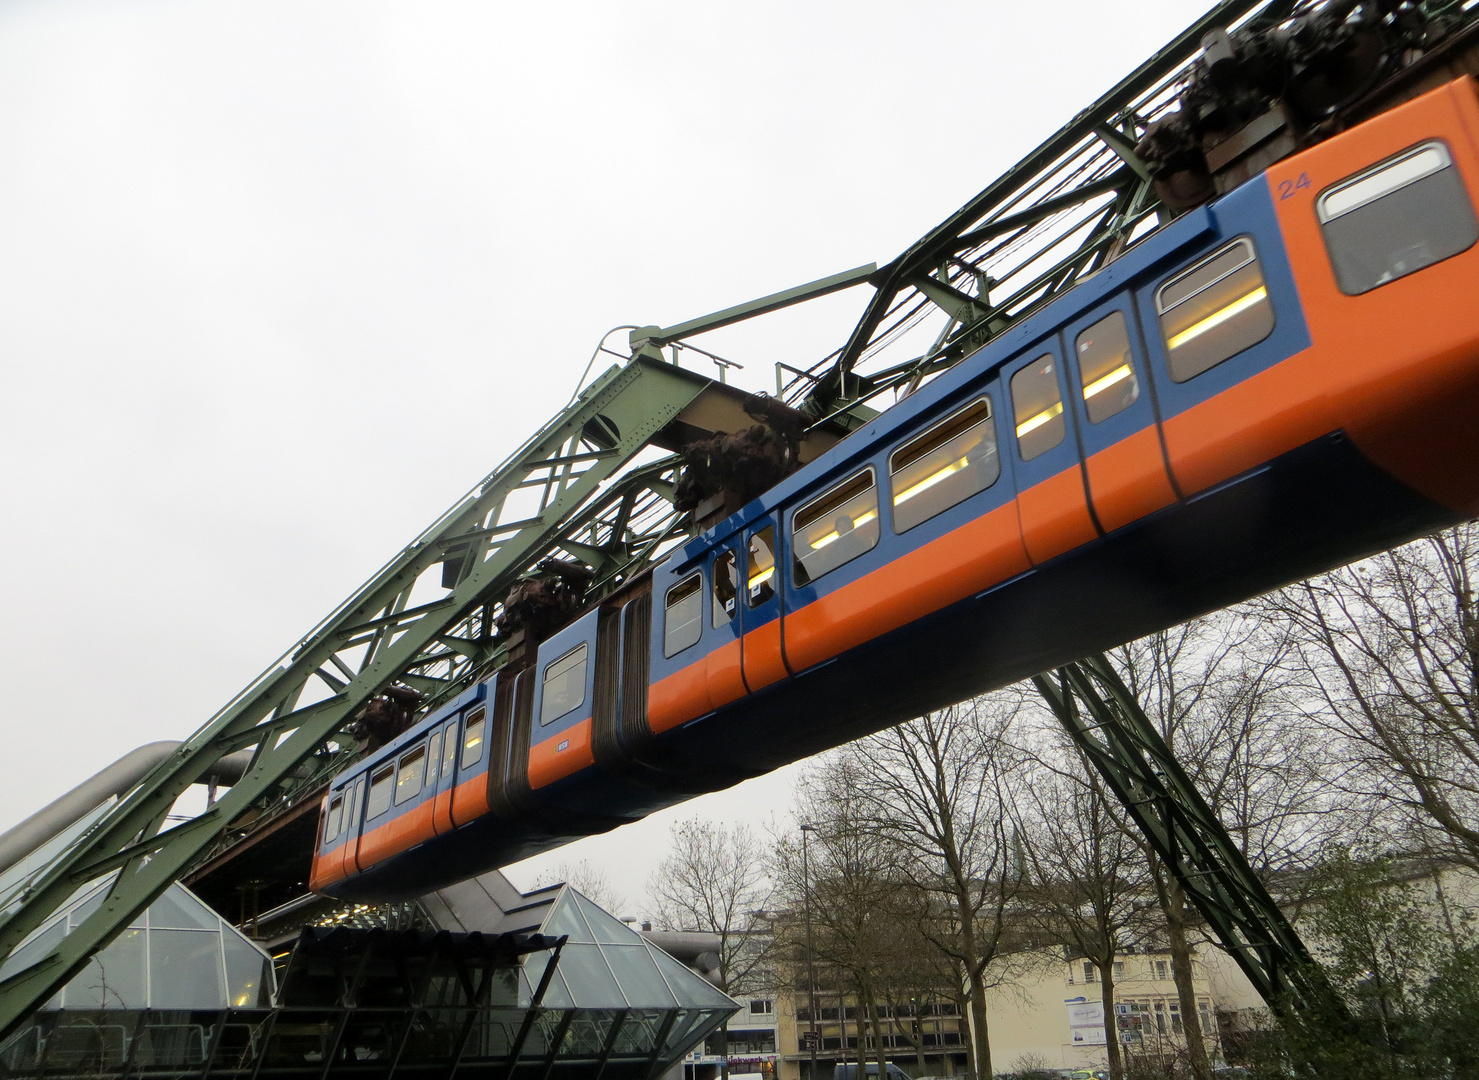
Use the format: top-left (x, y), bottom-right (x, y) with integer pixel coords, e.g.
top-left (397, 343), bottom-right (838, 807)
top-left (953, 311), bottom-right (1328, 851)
top-left (1315, 142), bottom-right (1479, 296)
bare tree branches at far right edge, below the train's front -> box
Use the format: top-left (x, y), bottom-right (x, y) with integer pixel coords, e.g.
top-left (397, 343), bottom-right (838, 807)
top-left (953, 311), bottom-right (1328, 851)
top-left (1259, 524), bottom-right (1479, 870)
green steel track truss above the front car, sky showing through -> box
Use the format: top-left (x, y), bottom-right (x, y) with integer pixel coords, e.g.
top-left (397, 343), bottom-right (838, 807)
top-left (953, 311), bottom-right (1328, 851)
top-left (784, 0), bottom-right (1296, 416)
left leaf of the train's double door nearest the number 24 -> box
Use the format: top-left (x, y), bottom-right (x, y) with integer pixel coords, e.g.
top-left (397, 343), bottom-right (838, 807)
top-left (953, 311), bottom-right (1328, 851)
top-left (1001, 337), bottom-right (1099, 565)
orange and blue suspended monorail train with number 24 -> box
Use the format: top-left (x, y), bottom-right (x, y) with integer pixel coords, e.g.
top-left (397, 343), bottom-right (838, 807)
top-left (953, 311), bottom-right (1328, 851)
top-left (312, 78), bottom-right (1479, 898)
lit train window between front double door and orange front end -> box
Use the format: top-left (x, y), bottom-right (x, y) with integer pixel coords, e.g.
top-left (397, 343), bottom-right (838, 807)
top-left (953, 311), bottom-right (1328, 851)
top-left (1155, 237), bottom-right (1273, 383)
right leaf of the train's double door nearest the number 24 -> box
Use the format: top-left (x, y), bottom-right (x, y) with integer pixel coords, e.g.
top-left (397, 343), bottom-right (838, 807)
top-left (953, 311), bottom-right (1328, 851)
top-left (1063, 294), bottom-right (1176, 533)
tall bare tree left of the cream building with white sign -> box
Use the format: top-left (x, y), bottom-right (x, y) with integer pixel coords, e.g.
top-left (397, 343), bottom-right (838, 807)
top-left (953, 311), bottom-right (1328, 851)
top-left (843, 698), bottom-right (1025, 1077)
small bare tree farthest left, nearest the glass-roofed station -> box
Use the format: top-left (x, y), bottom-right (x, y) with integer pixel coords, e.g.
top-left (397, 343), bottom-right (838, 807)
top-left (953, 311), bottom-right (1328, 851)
top-left (649, 818), bottom-right (774, 1077)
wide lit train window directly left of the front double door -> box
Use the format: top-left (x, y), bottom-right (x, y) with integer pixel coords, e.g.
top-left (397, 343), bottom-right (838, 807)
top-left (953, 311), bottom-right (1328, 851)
top-left (889, 398), bottom-right (1001, 533)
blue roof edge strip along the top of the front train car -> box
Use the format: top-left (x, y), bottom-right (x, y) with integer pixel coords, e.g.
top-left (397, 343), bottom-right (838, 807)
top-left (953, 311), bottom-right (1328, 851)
top-left (677, 202), bottom-right (1224, 571)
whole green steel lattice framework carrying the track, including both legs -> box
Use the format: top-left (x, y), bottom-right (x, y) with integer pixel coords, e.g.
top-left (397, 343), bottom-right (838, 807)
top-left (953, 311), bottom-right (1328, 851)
top-left (0, 0), bottom-right (1476, 1037)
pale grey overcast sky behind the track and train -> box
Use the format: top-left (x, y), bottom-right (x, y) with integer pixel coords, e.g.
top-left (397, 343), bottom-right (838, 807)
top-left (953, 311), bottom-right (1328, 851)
top-left (0, 0), bottom-right (1210, 907)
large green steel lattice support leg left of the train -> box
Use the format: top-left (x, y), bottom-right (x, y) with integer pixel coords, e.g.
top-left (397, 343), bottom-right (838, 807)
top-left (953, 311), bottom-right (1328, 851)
top-left (0, 358), bottom-right (710, 1039)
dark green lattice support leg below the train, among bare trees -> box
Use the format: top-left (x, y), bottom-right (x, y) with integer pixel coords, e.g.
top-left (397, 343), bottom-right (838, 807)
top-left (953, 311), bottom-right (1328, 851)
top-left (1032, 654), bottom-right (1346, 1024)
